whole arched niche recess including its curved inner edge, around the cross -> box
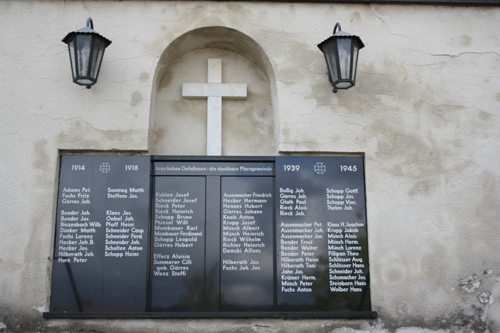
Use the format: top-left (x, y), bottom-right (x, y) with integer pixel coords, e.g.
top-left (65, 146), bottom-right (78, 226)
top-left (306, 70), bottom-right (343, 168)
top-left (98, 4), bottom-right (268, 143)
top-left (150, 27), bottom-right (278, 155)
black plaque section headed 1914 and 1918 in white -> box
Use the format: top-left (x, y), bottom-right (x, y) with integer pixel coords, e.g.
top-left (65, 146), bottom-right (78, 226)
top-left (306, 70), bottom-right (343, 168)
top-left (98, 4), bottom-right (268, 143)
top-left (51, 156), bottom-right (150, 312)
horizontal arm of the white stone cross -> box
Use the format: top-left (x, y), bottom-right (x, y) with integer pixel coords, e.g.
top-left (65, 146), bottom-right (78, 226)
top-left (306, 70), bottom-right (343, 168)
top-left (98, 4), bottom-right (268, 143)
top-left (182, 83), bottom-right (247, 99)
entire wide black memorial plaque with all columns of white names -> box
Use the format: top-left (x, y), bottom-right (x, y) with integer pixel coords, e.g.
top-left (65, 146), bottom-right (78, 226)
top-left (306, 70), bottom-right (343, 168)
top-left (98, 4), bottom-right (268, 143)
top-left (44, 156), bottom-right (376, 318)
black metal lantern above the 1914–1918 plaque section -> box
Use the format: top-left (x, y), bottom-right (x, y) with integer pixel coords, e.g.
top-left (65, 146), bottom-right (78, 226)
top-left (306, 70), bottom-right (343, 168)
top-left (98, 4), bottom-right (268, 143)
top-left (62, 17), bottom-right (111, 89)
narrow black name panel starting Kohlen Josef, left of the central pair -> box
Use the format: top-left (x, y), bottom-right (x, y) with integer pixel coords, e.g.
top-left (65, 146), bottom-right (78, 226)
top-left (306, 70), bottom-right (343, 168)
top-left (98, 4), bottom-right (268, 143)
top-left (151, 176), bottom-right (207, 312)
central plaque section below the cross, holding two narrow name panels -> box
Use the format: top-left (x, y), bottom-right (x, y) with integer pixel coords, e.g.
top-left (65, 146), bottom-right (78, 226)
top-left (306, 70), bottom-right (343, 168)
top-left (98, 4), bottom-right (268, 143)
top-left (151, 161), bottom-right (274, 312)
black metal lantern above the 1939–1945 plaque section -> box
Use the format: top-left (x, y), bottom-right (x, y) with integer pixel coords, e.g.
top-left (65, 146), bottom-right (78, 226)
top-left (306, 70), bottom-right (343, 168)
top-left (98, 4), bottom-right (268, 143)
top-left (318, 23), bottom-right (365, 93)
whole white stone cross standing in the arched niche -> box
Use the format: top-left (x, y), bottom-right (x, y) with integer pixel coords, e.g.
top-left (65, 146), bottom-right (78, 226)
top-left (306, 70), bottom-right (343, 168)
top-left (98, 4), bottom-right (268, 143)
top-left (182, 59), bottom-right (247, 155)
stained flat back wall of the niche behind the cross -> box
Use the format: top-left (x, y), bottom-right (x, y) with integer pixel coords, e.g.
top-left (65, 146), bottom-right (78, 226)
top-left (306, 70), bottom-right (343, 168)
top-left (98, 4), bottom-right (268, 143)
top-left (151, 49), bottom-right (276, 156)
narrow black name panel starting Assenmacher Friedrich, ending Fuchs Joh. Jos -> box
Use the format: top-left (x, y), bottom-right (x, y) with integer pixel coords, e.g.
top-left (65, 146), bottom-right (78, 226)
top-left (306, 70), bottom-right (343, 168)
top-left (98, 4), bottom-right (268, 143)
top-left (220, 177), bottom-right (274, 311)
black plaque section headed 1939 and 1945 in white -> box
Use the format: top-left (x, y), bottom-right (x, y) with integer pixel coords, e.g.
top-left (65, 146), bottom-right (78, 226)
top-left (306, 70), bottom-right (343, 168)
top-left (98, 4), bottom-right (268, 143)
top-left (276, 156), bottom-right (370, 311)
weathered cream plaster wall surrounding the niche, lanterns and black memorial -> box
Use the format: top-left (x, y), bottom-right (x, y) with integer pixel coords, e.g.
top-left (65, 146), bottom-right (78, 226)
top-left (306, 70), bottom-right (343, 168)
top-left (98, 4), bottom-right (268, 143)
top-left (0, 1), bottom-right (500, 332)
